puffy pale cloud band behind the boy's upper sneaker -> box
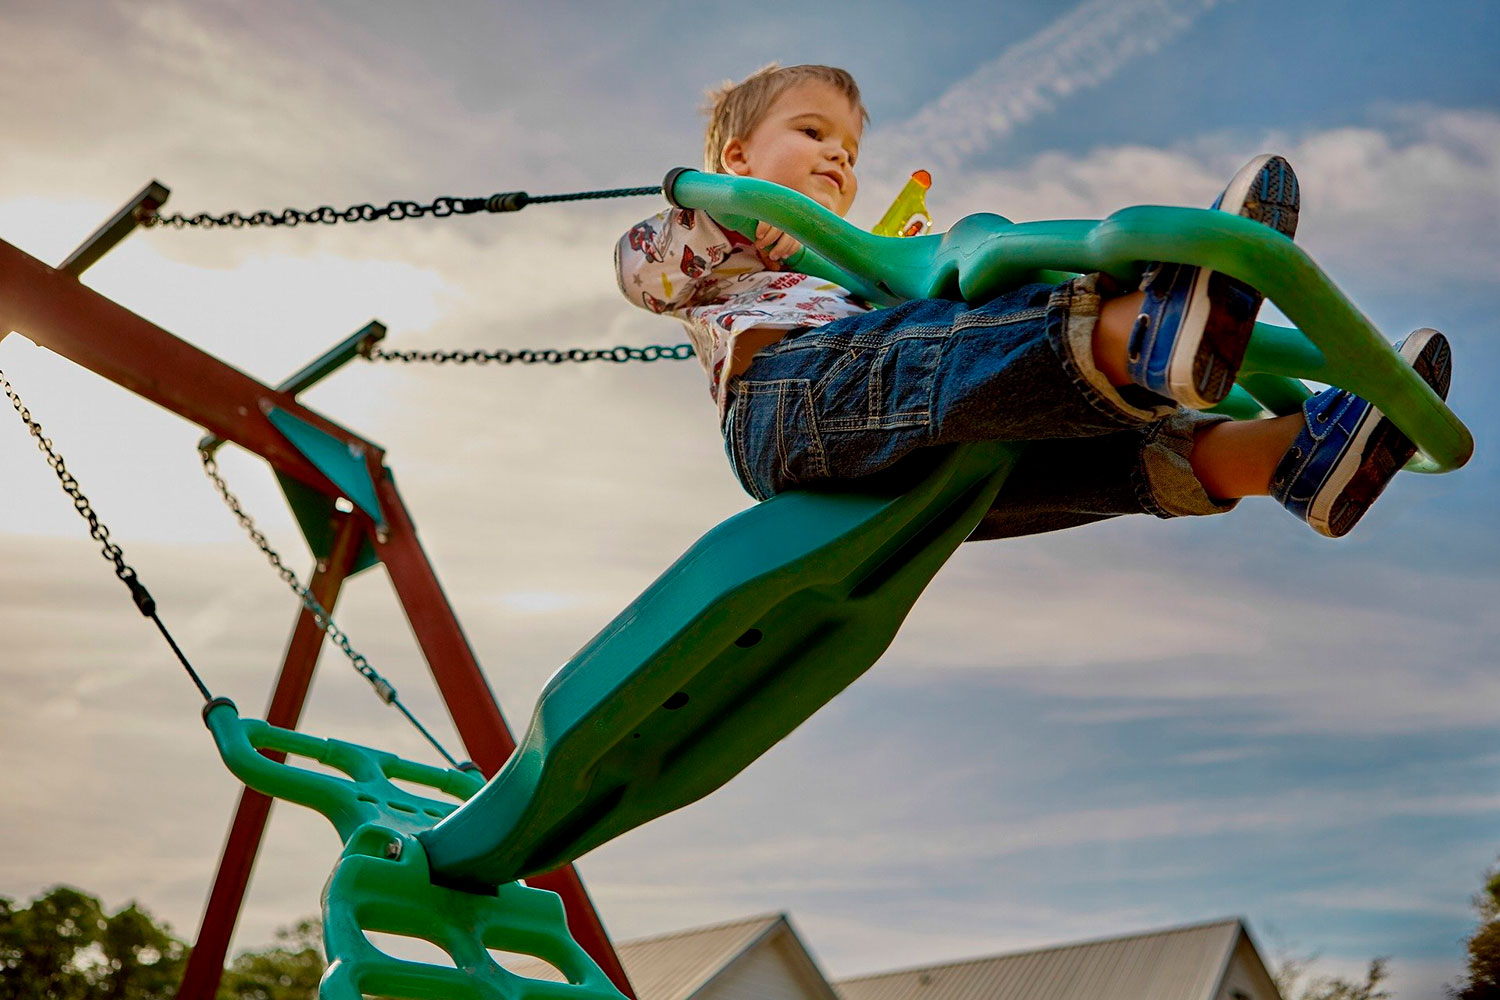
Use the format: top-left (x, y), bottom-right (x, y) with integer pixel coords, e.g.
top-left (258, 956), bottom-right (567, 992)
top-left (929, 105), bottom-right (1500, 299)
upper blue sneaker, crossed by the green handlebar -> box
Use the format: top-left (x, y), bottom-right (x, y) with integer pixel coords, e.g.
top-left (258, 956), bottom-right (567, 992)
top-left (1127, 154), bottom-right (1301, 409)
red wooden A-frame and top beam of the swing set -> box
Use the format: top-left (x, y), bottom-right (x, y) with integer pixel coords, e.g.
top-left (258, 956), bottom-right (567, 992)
top-left (0, 181), bottom-right (635, 1000)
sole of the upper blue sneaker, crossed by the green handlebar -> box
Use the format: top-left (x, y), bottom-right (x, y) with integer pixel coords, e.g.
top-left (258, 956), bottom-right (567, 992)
top-left (1167, 153), bottom-right (1301, 409)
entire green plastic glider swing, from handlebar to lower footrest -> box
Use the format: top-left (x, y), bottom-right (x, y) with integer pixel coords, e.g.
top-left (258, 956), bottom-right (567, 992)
top-left (196, 171), bottom-right (1473, 1000)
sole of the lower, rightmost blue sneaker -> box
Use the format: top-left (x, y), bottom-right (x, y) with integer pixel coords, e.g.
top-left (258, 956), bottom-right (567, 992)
top-left (1308, 328), bottom-right (1454, 538)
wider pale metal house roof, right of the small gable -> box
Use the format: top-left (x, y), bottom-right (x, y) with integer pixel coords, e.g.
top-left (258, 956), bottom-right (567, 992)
top-left (834, 918), bottom-right (1245, 1000)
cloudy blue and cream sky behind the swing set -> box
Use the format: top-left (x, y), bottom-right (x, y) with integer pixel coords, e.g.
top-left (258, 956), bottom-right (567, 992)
top-left (0, 0), bottom-right (1500, 1000)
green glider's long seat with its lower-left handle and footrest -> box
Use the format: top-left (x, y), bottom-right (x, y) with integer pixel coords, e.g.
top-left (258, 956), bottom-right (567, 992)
top-left (204, 442), bottom-right (1019, 1000)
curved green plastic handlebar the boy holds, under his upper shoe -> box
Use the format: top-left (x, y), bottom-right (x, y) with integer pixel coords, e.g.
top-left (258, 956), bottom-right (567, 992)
top-left (663, 171), bottom-right (1475, 472)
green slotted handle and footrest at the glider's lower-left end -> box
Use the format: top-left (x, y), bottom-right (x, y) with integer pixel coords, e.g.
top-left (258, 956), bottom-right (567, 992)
top-left (204, 699), bottom-right (624, 1000)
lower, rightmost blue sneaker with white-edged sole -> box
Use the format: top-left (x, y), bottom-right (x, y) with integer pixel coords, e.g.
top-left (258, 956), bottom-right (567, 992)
top-left (1271, 330), bottom-right (1454, 538)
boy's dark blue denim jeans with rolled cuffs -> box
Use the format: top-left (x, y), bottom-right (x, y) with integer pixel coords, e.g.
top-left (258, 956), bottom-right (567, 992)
top-left (723, 274), bottom-right (1235, 540)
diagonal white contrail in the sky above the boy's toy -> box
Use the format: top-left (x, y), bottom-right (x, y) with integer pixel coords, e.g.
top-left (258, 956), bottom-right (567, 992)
top-left (872, 0), bottom-right (1220, 175)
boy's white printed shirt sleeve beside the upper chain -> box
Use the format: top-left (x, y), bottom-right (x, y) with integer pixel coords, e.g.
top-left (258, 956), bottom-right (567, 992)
top-left (615, 208), bottom-right (729, 313)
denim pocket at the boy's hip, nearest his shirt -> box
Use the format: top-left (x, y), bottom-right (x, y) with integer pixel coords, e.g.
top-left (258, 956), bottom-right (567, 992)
top-left (731, 378), bottom-right (828, 499)
